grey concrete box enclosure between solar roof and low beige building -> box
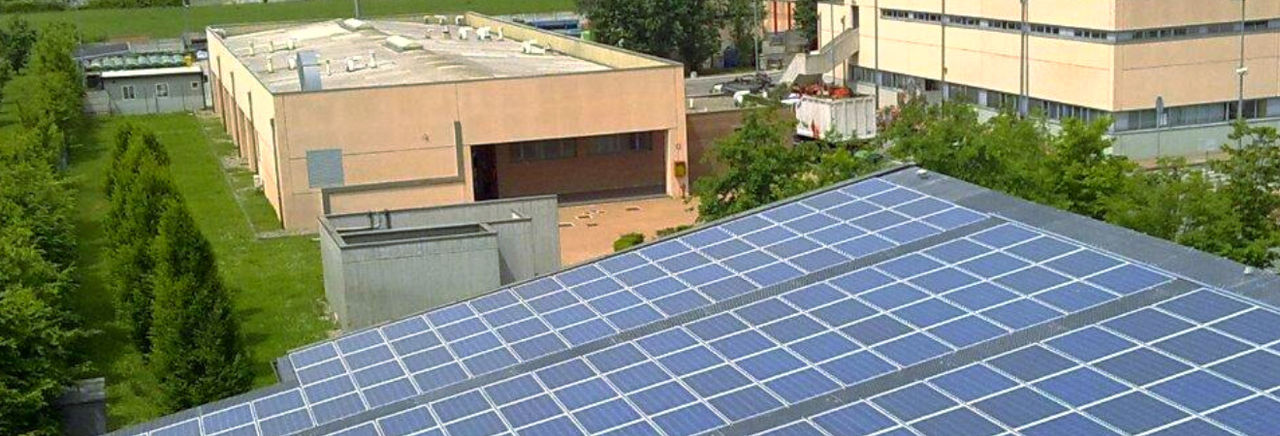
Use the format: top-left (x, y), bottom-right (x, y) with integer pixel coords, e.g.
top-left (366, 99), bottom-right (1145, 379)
top-left (319, 196), bottom-right (561, 329)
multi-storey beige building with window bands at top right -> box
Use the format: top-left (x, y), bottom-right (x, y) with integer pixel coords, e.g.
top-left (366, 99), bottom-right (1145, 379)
top-left (818, 0), bottom-right (1280, 157)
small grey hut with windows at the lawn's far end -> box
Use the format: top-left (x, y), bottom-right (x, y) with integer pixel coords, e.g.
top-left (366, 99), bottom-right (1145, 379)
top-left (101, 74), bottom-right (206, 115)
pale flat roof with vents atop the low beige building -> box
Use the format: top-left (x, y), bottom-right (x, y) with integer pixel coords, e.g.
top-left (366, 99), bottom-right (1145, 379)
top-left (223, 19), bottom-right (611, 92)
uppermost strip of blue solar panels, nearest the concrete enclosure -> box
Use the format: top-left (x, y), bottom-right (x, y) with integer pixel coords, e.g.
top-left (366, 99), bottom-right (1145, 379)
top-left (129, 179), bottom-right (986, 435)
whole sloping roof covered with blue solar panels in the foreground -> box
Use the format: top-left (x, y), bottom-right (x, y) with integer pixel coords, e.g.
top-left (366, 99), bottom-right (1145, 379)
top-left (110, 166), bottom-right (1280, 436)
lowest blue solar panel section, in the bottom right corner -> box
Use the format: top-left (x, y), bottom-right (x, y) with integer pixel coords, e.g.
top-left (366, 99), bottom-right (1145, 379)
top-left (768, 289), bottom-right (1280, 436)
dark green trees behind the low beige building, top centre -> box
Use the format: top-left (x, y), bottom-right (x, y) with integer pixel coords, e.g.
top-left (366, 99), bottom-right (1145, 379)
top-left (577, 0), bottom-right (762, 70)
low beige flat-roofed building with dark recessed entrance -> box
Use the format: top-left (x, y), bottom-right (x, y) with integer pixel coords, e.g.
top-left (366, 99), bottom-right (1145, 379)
top-left (207, 13), bottom-right (689, 230)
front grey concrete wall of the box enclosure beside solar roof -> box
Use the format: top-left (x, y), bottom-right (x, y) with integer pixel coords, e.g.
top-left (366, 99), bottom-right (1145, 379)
top-left (337, 228), bottom-right (500, 330)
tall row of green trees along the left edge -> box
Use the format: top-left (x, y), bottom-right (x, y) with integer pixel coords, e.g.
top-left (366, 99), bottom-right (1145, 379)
top-left (0, 18), bottom-right (84, 435)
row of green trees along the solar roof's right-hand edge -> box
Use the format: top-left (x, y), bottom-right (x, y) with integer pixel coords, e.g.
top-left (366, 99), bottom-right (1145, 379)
top-left (882, 101), bottom-right (1280, 267)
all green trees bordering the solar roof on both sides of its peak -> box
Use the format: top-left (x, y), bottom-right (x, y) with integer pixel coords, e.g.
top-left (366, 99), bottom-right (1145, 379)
top-left (694, 100), bottom-right (1280, 267)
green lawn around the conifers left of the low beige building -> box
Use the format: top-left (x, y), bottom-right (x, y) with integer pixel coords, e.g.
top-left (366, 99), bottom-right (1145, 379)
top-left (70, 114), bottom-right (333, 428)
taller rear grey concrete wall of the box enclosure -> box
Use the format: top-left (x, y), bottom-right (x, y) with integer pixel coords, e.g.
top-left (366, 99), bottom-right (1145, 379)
top-left (321, 196), bottom-right (561, 284)
